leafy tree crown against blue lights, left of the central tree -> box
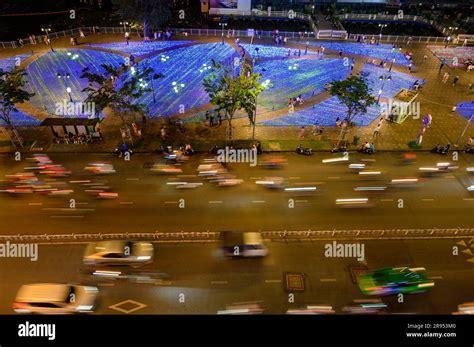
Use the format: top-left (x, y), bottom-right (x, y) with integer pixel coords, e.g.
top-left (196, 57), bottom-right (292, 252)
top-left (81, 64), bottom-right (162, 124)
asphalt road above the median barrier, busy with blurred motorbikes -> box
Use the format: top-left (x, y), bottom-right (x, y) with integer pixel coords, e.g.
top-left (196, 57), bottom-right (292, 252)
top-left (0, 153), bottom-right (474, 235)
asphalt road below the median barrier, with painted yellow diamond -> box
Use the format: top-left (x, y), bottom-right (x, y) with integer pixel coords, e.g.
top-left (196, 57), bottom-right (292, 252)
top-left (0, 239), bottom-right (474, 314)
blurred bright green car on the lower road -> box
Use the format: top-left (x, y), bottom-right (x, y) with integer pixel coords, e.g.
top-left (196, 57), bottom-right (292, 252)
top-left (357, 267), bottom-right (434, 295)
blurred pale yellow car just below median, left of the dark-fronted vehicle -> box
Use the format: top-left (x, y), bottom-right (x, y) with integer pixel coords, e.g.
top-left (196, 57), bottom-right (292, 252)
top-left (83, 241), bottom-right (153, 266)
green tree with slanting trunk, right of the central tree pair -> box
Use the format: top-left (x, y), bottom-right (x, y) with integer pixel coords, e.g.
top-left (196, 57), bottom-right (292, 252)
top-left (329, 76), bottom-right (375, 146)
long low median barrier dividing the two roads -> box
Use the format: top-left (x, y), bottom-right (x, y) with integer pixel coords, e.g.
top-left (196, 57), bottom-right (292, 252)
top-left (0, 228), bottom-right (474, 243)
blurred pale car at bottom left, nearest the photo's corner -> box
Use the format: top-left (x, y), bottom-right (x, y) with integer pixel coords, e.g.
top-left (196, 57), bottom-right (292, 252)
top-left (12, 283), bottom-right (99, 314)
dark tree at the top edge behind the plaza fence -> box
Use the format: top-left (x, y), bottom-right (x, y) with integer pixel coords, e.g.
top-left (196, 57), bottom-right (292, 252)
top-left (112, 0), bottom-right (171, 36)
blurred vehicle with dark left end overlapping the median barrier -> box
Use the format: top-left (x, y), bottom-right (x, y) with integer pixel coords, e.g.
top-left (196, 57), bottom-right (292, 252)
top-left (221, 231), bottom-right (268, 258)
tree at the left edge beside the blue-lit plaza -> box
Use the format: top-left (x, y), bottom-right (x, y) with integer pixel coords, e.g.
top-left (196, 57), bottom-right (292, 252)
top-left (0, 69), bottom-right (35, 146)
